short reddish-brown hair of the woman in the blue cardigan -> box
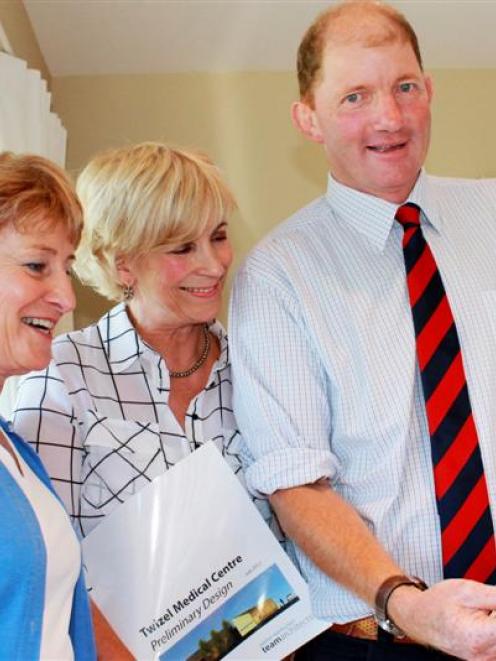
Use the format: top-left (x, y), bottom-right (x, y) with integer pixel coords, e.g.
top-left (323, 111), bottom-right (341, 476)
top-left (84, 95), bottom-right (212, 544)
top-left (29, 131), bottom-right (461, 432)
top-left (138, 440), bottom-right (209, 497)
top-left (0, 152), bottom-right (83, 246)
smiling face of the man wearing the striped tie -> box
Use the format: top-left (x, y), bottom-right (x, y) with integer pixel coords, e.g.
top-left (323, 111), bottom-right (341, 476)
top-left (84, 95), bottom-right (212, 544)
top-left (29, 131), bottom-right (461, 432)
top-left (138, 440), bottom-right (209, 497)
top-left (294, 41), bottom-right (432, 203)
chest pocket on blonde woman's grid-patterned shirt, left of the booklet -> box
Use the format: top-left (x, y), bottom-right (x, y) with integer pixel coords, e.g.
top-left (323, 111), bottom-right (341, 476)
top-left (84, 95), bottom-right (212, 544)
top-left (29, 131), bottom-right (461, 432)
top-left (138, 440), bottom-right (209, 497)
top-left (81, 418), bottom-right (166, 518)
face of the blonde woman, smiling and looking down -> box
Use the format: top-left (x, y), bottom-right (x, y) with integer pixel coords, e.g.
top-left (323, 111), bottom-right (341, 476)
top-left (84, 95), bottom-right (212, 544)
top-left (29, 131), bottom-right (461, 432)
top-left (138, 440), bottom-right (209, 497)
top-left (124, 221), bottom-right (233, 328)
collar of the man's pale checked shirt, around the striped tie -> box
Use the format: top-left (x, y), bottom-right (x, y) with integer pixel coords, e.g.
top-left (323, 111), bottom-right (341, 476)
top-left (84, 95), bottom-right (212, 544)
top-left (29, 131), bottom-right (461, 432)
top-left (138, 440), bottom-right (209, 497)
top-left (326, 170), bottom-right (442, 252)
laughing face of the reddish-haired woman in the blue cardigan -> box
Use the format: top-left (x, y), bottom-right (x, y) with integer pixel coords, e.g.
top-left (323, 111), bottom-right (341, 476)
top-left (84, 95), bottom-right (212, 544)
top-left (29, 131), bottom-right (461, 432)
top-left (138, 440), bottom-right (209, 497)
top-left (0, 219), bottom-right (76, 385)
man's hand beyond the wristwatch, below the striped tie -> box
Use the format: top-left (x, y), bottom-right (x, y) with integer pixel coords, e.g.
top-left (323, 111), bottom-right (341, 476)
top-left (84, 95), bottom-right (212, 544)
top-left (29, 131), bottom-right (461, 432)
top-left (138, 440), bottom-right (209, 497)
top-left (388, 579), bottom-right (496, 661)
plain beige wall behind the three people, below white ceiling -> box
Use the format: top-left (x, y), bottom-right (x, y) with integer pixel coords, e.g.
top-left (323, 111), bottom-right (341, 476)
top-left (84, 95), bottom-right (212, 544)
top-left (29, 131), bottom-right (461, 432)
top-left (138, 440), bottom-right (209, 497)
top-left (53, 70), bottom-right (496, 325)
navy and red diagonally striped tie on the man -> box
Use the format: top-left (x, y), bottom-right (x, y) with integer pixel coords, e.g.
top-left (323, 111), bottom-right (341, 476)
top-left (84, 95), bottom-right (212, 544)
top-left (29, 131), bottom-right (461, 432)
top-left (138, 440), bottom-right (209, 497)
top-left (395, 203), bottom-right (496, 584)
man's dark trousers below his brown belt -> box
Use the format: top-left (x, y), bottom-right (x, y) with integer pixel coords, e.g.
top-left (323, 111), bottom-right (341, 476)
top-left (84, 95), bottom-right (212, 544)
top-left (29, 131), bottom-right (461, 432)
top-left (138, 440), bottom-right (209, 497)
top-left (294, 630), bottom-right (455, 661)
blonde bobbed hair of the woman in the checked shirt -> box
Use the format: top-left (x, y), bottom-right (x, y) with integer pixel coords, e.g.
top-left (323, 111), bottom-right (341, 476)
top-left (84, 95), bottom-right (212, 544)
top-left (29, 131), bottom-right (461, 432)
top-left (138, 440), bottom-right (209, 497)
top-left (75, 142), bottom-right (236, 300)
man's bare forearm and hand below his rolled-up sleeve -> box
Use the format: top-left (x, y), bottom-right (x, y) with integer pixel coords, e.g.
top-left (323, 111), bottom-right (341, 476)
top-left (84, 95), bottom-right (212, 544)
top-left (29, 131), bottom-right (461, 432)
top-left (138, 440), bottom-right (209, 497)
top-left (270, 483), bottom-right (496, 661)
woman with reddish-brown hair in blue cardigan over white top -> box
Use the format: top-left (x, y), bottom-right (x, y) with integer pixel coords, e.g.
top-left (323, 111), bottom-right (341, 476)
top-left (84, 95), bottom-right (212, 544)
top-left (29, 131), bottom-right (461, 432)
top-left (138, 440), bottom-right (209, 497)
top-left (0, 153), bottom-right (96, 661)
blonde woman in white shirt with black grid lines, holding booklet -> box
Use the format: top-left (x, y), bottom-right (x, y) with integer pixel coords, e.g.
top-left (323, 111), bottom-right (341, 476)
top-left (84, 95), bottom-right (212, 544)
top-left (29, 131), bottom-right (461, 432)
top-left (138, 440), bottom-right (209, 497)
top-left (14, 143), bottom-right (248, 656)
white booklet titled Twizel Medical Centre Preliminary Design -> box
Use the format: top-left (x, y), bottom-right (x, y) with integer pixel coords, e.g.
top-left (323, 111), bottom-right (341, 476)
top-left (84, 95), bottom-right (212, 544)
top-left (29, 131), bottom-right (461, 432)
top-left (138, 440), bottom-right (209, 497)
top-left (83, 442), bottom-right (330, 661)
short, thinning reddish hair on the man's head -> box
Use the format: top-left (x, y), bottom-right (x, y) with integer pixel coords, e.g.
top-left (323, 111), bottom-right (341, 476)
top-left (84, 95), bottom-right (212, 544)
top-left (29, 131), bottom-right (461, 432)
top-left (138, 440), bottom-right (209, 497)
top-left (297, 0), bottom-right (423, 105)
